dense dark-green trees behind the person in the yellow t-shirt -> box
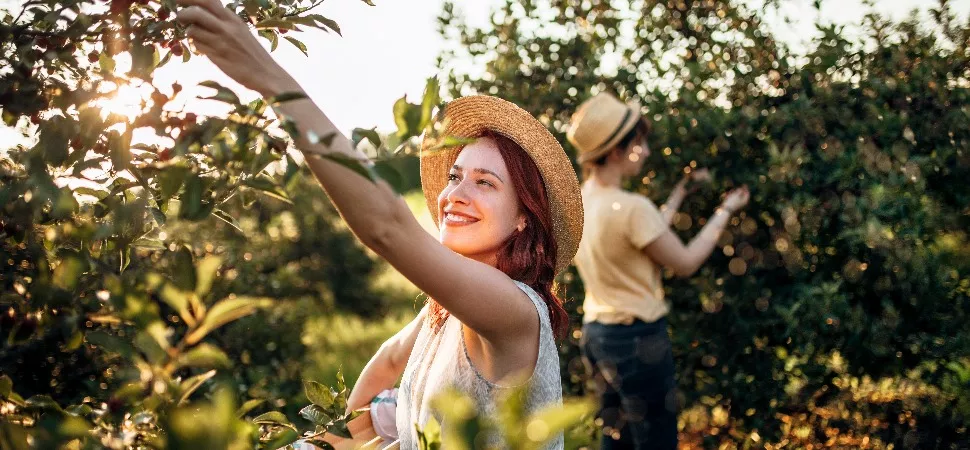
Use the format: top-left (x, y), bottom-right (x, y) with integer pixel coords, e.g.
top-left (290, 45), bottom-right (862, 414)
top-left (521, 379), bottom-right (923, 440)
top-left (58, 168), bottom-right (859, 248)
top-left (439, 0), bottom-right (970, 448)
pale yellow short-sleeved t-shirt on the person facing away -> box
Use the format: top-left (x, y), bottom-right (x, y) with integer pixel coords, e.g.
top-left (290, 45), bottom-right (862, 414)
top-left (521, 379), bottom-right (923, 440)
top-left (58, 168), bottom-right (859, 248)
top-left (575, 182), bottom-right (669, 324)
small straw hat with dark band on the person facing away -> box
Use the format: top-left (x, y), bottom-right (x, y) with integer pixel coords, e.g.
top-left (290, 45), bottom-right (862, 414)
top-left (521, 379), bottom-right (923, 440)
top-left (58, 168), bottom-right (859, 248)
top-left (566, 92), bottom-right (649, 164)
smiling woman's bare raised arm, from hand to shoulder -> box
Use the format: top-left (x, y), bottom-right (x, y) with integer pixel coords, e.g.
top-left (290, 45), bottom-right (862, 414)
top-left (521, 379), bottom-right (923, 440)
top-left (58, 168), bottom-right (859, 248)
top-left (178, 0), bottom-right (539, 346)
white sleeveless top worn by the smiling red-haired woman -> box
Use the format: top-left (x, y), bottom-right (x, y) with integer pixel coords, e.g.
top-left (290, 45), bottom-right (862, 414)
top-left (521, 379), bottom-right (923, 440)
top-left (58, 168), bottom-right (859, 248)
top-left (396, 281), bottom-right (563, 450)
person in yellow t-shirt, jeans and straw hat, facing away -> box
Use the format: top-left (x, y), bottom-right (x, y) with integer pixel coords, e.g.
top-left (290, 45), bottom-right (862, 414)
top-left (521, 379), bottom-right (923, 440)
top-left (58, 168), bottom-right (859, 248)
top-left (567, 94), bottom-right (749, 449)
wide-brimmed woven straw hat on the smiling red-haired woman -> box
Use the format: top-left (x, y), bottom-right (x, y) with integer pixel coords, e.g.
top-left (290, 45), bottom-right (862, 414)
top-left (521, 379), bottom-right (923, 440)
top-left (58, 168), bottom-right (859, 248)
top-left (421, 95), bottom-right (583, 273)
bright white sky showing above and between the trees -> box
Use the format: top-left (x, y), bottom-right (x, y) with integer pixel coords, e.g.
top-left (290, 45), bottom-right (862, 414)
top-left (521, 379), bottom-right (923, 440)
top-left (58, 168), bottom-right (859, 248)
top-left (0, 0), bottom-right (970, 143)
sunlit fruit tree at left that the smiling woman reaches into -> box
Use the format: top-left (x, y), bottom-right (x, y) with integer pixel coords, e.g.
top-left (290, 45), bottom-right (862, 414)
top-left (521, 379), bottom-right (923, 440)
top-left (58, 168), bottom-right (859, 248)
top-left (0, 0), bottom-right (437, 449)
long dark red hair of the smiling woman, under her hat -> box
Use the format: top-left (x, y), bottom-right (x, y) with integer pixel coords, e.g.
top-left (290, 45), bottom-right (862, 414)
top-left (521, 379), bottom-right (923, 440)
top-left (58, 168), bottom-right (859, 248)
top-left (428, 131), bottom-right (569, 340)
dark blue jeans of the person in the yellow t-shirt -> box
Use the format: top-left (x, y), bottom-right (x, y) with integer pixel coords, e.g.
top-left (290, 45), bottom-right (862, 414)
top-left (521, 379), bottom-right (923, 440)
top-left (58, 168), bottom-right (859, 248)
top-left (580, 318), bottom-right (678, 450)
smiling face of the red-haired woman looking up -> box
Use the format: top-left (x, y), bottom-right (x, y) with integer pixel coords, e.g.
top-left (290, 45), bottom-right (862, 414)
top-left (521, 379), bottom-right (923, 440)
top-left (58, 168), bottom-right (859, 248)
top-left (438, 137), bottom-right (525, 266)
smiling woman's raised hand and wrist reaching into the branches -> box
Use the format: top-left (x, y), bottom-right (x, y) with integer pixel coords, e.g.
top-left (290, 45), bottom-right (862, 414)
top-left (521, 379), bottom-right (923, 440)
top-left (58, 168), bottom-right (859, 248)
top-left (178, 0), bottom-right (299, 97)
